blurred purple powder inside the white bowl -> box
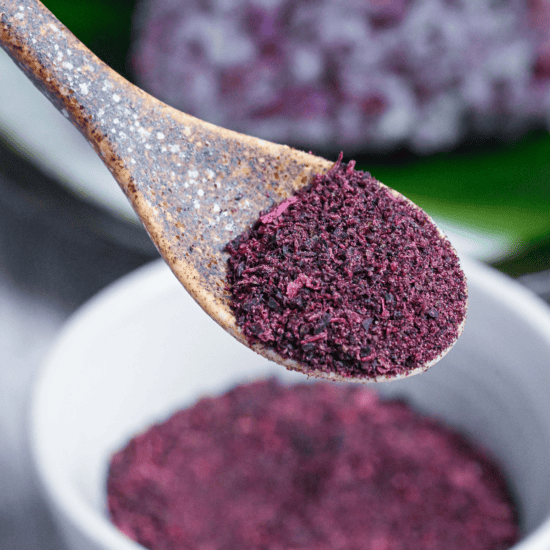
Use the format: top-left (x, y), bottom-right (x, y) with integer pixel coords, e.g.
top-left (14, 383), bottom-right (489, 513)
top-left (107, 380), bottom-right (518, 550)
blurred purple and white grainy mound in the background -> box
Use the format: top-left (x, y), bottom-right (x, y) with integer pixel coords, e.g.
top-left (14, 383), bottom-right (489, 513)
top-left (132, 0), bottom-right (550, 153)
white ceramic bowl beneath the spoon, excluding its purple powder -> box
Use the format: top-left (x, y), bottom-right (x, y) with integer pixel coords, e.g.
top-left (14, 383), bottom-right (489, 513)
top-left (31, 261), bottom-right (550, 550)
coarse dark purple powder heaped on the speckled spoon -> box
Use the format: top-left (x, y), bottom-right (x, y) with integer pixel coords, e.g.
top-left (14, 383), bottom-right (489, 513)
top-left (227, 155), bottom-right (467, 379)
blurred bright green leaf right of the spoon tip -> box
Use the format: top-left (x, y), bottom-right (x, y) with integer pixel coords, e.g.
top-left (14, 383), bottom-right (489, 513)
top-left (358, 132), bottom-right (550, 243)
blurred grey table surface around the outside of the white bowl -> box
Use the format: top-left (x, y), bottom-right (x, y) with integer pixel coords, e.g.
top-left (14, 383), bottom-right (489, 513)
top-left (0, 146), bottom-right (550, 550)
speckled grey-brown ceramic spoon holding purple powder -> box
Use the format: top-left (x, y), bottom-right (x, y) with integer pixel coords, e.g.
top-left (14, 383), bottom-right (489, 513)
top-left (0, 0), bottom-right (468, 382)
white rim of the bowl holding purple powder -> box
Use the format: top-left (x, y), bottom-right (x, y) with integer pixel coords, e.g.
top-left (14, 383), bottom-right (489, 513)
top-left (29, 258), bottom-right (550, 550)
